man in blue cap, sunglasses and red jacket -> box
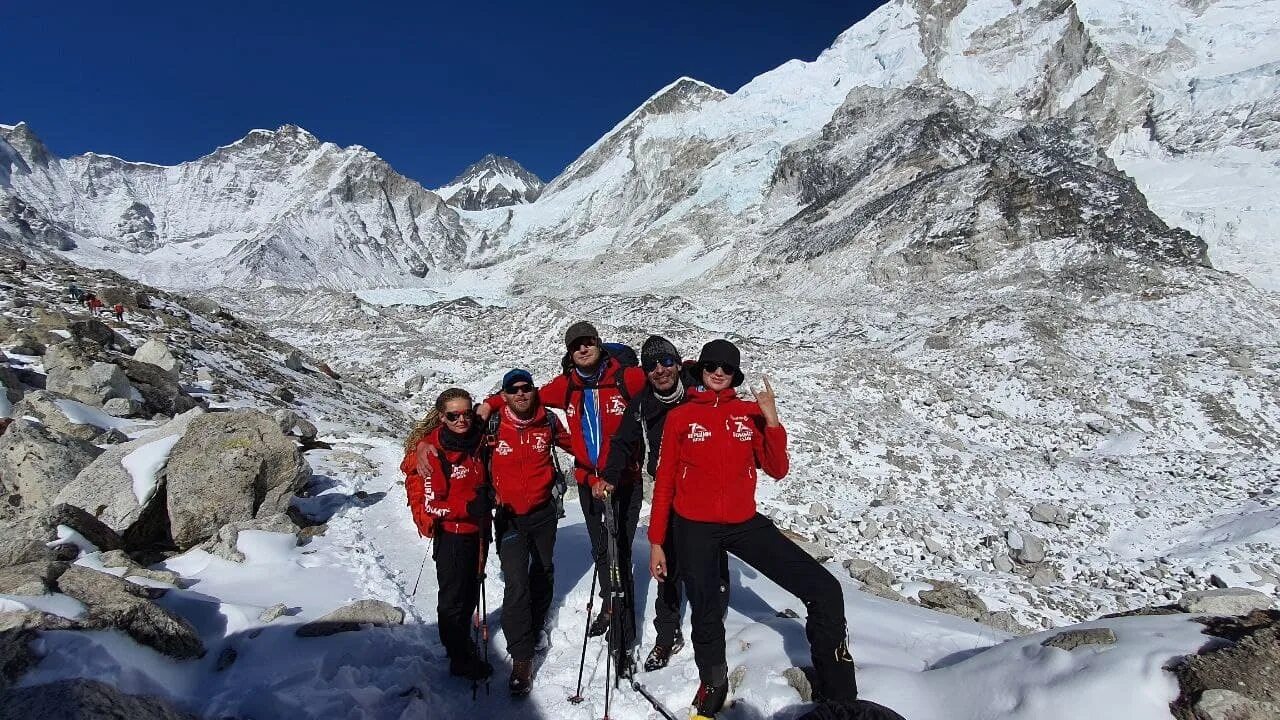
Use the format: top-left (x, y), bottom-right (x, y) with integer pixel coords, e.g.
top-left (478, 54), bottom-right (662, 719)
top-left (489, 368), bottom-right (568, 697)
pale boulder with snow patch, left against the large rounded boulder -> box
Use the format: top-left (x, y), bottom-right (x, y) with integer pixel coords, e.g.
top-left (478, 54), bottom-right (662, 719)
top-left (58, 407), bottom-right (204, 539)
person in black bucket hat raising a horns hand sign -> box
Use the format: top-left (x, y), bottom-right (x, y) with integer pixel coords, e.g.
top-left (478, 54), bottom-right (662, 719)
top-left (649, 340), bottom-right (858, 717)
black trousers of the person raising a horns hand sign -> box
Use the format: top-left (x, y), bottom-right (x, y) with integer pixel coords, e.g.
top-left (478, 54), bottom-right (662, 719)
top-left (672, 514), bottom-right (858, 701)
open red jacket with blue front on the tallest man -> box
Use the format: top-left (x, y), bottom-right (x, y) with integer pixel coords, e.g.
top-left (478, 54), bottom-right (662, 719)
top-left (485, 356), bottom-right (645, 487)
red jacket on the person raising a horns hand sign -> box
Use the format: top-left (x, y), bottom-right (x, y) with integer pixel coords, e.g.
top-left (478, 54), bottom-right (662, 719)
top-left (649, 388), bottom-right (788, 544)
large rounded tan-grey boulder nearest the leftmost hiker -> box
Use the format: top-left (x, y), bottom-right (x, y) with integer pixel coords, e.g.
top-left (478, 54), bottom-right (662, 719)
top-left (168, 410), bottom-right (311, 550)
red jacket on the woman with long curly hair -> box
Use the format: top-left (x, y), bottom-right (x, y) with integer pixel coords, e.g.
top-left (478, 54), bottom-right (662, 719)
top-left (401, 428), bottom-right (485, 537)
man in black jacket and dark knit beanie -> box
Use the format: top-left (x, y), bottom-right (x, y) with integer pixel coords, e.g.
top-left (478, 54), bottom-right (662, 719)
top-left (604, 336), bottom-right (728, 673)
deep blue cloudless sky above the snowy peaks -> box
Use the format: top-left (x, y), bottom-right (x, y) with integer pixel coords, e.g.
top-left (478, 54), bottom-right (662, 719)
top-left (0, 0), bottom-right (879, 187)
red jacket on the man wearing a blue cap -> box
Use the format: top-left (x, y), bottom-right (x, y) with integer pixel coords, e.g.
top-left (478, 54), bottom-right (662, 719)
top-left (489, 406), bottom-right (568, 515)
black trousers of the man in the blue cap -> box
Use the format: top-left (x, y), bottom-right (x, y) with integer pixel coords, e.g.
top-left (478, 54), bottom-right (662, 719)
top-left (494, 502), bottom-right (558, 660)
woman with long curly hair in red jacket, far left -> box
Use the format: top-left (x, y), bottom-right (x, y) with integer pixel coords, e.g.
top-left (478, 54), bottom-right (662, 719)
top-left (401, 388), bottom-right (493, 679)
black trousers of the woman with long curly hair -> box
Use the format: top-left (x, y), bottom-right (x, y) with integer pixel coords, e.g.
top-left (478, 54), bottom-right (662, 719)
top-left (433, 530), bottom-right (480, 657)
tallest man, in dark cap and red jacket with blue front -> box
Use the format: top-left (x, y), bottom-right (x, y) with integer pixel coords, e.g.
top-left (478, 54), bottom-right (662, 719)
top-left (479, 322), bottom-right (646, 662)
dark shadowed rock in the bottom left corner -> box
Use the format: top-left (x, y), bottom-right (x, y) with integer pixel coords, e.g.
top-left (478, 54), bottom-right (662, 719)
top-left (0, 679), bottom-right (198, 720)
